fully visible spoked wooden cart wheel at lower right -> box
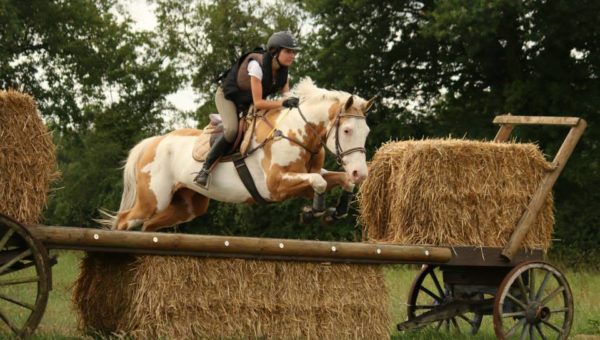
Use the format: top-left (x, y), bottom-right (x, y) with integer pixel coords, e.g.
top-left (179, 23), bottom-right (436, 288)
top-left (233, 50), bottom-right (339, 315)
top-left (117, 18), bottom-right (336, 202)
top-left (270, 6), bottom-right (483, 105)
top-left (494, 262), bottom-right (573, 339)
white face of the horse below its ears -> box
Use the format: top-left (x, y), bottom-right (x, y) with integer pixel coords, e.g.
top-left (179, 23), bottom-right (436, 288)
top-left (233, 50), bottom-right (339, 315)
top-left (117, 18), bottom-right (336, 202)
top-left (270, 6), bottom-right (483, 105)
top-left (327, 117), bottom-right (370, 184)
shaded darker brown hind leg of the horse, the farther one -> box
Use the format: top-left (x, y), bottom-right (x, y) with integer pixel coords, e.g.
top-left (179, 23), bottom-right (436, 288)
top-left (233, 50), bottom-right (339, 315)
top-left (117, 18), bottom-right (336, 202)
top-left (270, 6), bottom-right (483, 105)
top-left (142, 188), bottom-right (209, 231)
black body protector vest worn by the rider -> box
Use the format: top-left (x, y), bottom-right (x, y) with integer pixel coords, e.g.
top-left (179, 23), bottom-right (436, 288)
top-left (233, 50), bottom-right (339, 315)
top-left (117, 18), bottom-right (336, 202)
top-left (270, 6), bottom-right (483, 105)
top-left (223, 52), bottom-right (288, 113)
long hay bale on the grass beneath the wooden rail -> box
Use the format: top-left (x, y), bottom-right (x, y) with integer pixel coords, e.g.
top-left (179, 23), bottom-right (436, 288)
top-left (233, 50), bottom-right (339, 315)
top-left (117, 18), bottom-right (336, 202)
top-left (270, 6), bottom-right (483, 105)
top-left (73, 254), bottom-right (390, 339)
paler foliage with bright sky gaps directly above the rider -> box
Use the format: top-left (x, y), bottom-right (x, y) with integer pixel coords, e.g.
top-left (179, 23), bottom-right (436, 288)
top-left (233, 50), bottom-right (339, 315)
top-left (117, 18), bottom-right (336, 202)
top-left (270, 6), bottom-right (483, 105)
top-left (157, 0), bottom-right (300, 122)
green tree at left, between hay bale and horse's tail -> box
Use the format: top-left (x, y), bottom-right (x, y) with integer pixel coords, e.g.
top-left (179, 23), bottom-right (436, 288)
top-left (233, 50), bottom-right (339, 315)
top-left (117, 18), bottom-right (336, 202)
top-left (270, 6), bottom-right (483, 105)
top-left (0, 0), bottom-right (181, 225)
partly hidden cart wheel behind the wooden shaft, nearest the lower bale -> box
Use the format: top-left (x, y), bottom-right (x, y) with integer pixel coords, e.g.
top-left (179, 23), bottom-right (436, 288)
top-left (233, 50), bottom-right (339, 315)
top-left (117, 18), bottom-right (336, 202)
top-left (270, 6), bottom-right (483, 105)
top-left (407, 265), bottom-right (483, 334)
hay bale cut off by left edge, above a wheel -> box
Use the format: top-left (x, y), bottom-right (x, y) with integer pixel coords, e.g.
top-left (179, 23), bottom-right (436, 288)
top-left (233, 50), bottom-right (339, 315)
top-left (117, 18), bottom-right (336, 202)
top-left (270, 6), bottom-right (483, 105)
top-left (0, 91), bottom-right (57, 223)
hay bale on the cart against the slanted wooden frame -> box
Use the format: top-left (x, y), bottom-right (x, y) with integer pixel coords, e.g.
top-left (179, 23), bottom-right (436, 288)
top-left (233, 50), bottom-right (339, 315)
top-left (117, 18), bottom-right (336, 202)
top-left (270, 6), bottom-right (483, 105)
top-left (358, 139), bottom-right (554, 250)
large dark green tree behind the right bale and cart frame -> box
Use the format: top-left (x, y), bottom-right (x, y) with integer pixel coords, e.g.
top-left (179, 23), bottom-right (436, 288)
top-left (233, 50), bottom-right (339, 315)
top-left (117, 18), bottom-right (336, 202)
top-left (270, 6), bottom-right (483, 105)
top-left (299, 0), bottom-right (600, 252)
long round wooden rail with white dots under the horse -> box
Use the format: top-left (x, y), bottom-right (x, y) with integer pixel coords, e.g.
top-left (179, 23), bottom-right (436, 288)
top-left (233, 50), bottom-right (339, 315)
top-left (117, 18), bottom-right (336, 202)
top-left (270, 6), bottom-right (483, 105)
top-left (27, 225), bottom-right (452, 264)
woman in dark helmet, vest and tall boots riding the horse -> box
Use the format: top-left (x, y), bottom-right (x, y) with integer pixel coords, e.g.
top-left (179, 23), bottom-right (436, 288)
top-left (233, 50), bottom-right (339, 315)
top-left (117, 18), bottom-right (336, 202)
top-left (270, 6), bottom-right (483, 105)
top-left (194, 32), bottom-right (300, 187)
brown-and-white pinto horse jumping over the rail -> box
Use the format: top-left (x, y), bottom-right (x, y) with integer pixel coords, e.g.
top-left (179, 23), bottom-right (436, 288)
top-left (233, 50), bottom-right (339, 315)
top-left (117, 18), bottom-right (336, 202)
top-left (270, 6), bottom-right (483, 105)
top-left (109, 78), bottom-right (374, 231)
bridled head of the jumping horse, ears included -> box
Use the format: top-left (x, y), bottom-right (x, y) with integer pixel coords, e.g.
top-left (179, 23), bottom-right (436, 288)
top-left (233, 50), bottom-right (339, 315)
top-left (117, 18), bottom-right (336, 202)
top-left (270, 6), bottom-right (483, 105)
top-left (326, 96), bottom-right (375, 184)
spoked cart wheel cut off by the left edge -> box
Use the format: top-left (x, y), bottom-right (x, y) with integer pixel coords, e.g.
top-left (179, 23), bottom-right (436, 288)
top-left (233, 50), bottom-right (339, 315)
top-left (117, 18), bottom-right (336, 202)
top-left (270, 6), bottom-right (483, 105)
top-left (0, 214), bottom-right (51, 338)
